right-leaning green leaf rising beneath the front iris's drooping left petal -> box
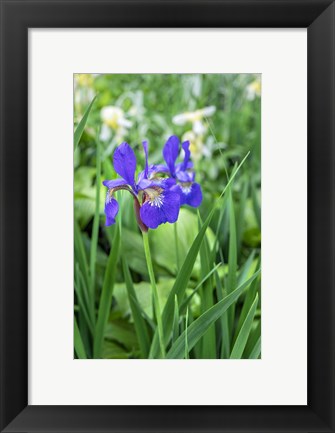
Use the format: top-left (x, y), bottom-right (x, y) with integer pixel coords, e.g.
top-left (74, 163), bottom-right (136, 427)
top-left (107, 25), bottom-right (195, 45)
top-left (93, 225), bottom-right (120, 359)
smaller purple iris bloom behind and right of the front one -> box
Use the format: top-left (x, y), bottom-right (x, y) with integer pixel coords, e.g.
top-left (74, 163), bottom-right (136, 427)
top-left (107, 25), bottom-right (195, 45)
top-left (159, 135), bottom-right (202, 207)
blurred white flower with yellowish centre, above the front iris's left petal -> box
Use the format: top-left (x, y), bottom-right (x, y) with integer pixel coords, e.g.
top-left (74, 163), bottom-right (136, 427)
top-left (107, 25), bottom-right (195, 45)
top-left (100, 105), bottom-right (132, 141)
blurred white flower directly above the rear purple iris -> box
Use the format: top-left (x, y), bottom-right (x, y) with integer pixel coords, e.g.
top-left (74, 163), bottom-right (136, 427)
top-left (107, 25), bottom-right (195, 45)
top-left (172, 105), bottom-right (216, 160)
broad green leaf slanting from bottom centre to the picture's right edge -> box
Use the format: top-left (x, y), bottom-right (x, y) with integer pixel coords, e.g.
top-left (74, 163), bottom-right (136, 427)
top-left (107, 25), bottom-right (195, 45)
top-left (167, 272), bottom-right (258, 359)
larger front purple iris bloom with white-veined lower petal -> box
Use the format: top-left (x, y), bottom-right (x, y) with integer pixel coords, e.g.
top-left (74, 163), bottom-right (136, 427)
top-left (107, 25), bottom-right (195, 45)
top-left (103, 141), bottom-right (180, 231)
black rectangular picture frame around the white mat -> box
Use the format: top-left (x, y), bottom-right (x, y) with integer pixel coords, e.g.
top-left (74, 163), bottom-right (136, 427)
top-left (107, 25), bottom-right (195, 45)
top-left (0, 0), bottom-right (335, 433)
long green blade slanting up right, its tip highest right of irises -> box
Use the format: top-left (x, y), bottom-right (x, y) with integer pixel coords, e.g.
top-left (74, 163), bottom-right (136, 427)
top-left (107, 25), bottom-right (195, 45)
top-left (149, 152), bottom-right (250, 358)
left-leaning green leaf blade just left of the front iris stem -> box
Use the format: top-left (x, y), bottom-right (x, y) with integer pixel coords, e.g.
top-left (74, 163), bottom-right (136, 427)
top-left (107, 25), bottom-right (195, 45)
top-left (122, 257), bottom-right (150, 359)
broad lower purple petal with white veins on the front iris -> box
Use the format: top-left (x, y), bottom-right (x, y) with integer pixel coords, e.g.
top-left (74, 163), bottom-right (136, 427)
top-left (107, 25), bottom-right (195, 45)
top-left (140, 189), bottom-right (180, 229)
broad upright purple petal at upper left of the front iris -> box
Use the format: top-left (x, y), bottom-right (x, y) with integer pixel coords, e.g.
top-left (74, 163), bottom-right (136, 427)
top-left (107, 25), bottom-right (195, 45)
top-left (113, 142), bottom-right (136, 190)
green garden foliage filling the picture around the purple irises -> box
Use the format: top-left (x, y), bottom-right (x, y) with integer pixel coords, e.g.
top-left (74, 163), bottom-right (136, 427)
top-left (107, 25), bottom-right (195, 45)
top-left (74, 74), bottom-right (261, 359)
